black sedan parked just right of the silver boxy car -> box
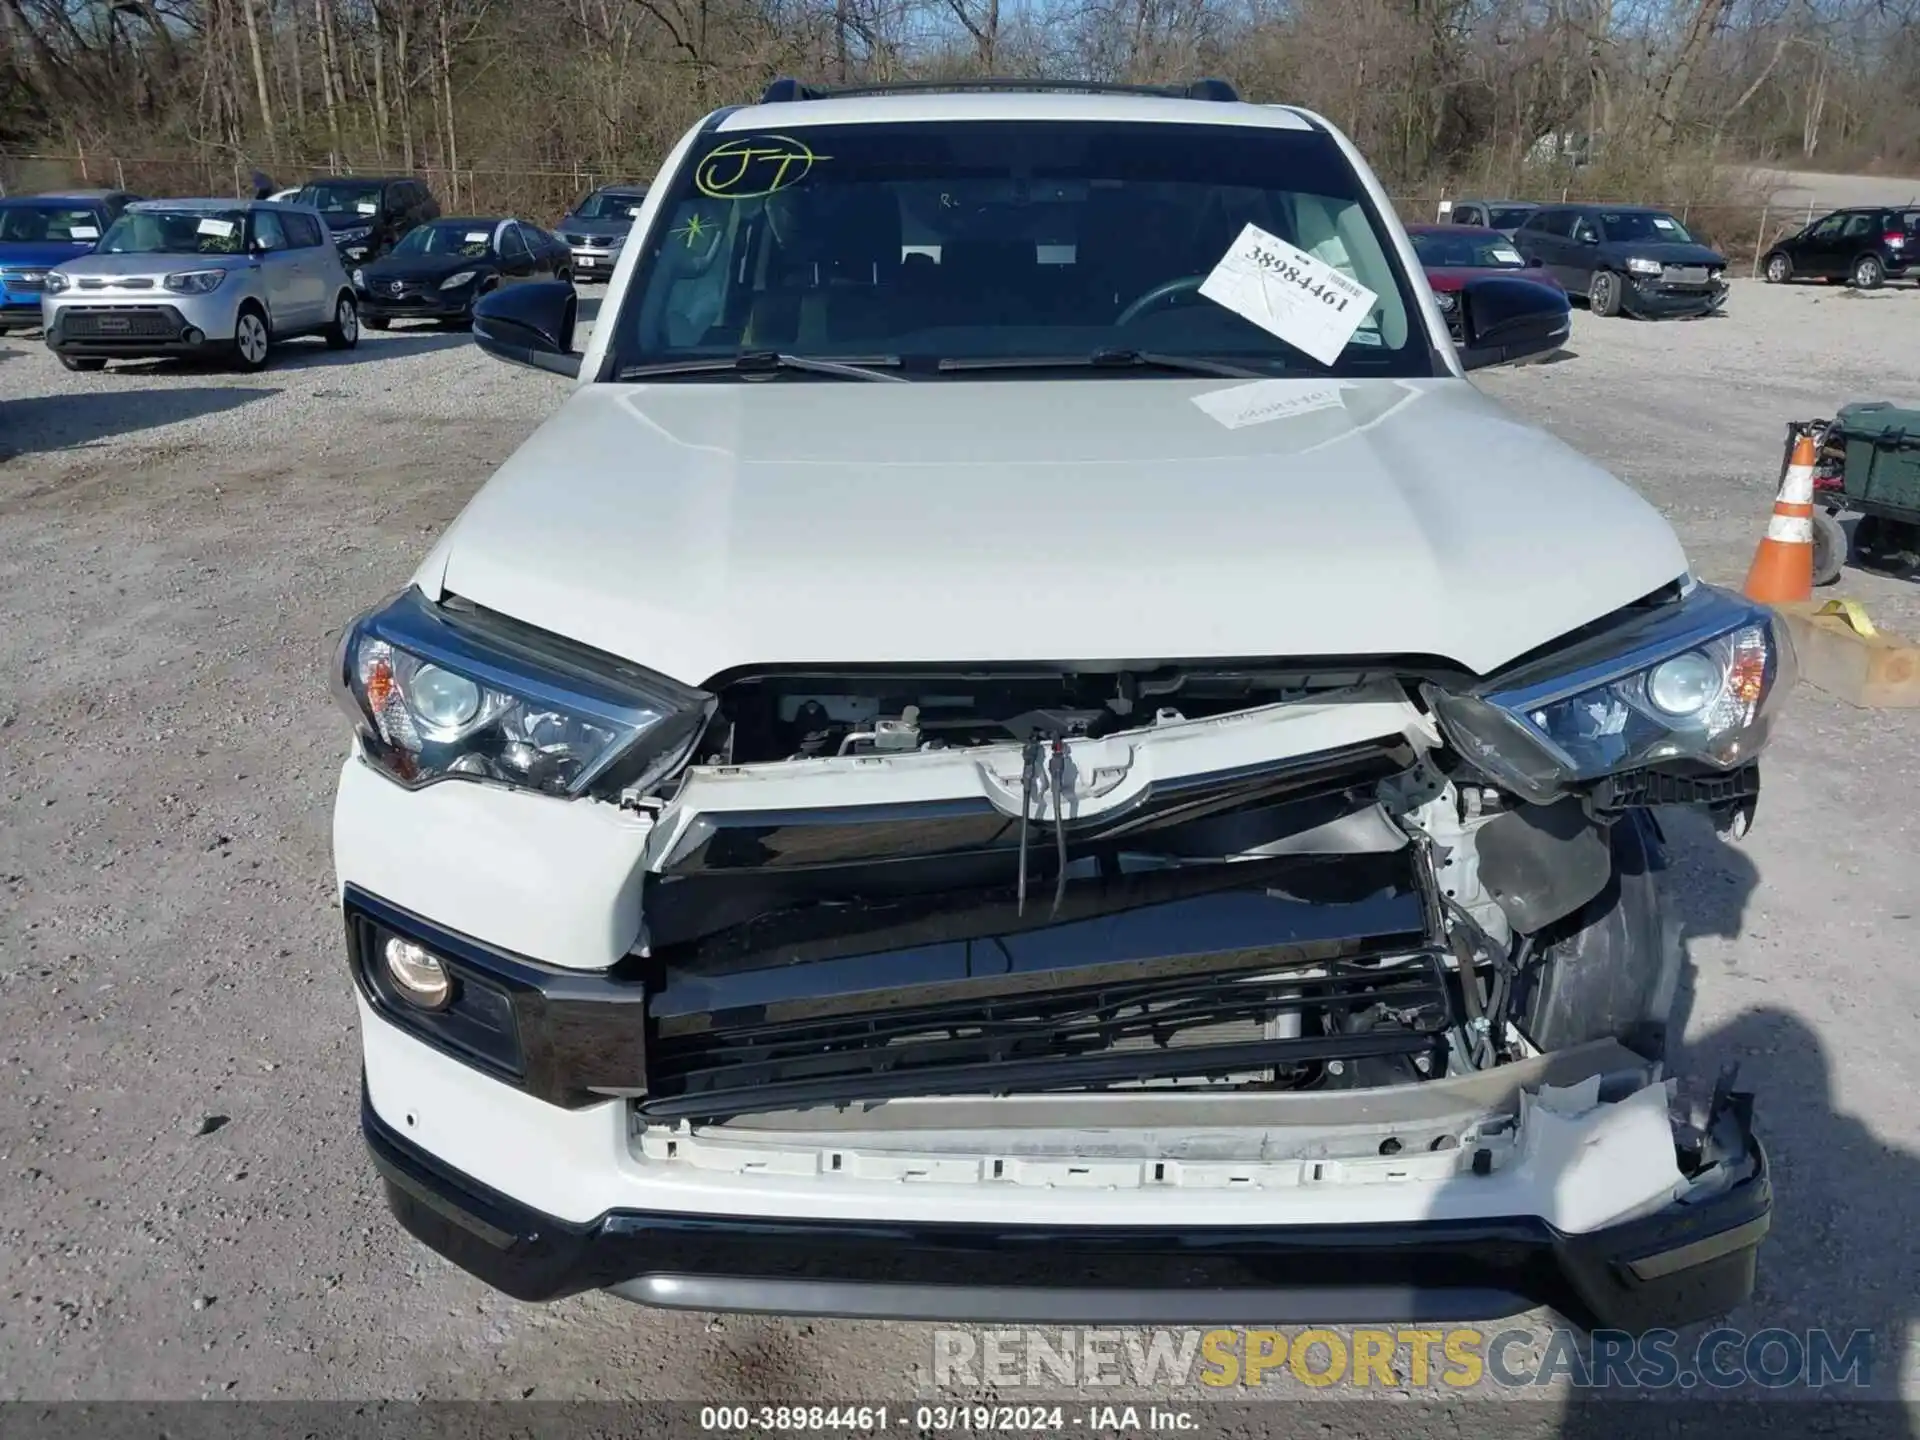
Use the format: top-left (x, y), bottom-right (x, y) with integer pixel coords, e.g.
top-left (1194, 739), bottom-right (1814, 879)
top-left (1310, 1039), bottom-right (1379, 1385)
top-left (353, 215), bottom-right (572, 330)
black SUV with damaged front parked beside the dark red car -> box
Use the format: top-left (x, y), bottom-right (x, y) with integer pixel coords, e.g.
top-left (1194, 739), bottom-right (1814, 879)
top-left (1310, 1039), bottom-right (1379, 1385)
top-left (1513, 205), bottom-right (1726, 321)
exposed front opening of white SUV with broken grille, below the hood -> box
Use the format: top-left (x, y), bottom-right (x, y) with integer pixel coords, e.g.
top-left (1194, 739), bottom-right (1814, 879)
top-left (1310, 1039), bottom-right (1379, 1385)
top-left (626, 672), bottom-right (1672, 1121)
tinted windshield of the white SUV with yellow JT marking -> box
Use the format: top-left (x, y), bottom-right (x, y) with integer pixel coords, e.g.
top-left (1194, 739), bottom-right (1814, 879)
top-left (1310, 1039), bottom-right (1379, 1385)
top-left (612, 121), bottom-right (1434, 376)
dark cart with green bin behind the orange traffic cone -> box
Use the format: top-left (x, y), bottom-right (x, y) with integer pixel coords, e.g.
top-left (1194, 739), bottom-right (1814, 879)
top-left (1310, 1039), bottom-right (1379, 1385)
top-left (1782, 399), bottom-right (1920, 586)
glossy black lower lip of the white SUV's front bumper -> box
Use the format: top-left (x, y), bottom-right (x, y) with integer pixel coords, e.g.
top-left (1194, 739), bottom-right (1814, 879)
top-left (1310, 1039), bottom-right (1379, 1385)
top-left (361, 1091), bottom-right (1772, 1332)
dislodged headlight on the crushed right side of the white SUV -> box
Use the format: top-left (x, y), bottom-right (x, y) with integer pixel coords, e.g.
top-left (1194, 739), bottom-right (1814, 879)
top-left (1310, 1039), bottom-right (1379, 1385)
top-left (1423, 586), bottom-right (1793, 803)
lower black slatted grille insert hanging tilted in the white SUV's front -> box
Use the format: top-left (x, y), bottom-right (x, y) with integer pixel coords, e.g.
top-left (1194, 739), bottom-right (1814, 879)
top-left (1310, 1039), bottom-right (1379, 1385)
top-left (639, 952), bottom-right (1452, 1117)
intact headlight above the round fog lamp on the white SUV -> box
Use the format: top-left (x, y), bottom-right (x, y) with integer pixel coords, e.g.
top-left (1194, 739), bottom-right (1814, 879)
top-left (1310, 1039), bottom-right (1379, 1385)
top-left (334, 589), bottom-right (712, 795)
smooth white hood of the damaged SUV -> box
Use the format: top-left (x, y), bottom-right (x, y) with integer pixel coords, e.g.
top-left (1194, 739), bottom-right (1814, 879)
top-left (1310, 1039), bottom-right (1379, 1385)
top-left (419, 376), bottom-right (1686, 685)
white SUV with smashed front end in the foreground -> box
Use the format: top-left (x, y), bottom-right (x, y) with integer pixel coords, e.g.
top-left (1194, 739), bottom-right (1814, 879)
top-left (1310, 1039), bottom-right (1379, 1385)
top-left (334, 81), bottom-right (1791, 1329)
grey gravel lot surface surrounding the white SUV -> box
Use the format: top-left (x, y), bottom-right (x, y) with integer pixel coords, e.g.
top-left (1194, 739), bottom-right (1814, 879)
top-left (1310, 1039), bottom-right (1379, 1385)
top-left (0, 284), bottom-right (1920, 1434)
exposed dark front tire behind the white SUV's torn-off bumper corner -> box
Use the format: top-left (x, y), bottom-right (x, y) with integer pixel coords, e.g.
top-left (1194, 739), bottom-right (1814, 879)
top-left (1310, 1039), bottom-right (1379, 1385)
top-left (1513, 810), bottom-right (1682, 1062)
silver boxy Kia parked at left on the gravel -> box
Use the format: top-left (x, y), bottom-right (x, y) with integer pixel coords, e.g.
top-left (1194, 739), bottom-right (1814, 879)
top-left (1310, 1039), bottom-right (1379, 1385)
top-left (40, 200), bottom-right (359, 371)
